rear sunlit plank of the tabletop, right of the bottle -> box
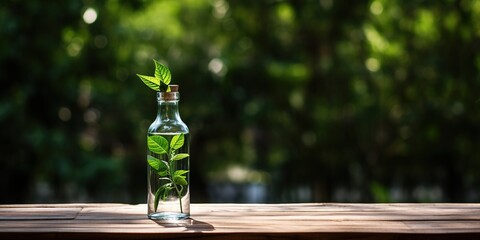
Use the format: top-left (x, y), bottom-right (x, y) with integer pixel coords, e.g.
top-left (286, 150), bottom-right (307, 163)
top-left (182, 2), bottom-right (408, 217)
top-left (192, 204), bottom-right (480, 221)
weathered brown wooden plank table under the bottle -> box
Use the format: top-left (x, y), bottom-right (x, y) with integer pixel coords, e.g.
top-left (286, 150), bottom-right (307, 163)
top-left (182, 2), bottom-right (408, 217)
top-left (0, 203), bottom-right (480, 239)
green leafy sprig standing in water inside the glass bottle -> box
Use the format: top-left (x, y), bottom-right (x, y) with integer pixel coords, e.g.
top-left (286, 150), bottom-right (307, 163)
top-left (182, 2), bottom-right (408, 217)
top-left (147, 133), bottom-right (190, 213)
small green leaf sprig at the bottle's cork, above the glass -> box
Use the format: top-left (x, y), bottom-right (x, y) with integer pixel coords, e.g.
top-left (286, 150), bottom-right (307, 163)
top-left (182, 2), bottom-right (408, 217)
top-left (137, 59), bottom-right (172, 92)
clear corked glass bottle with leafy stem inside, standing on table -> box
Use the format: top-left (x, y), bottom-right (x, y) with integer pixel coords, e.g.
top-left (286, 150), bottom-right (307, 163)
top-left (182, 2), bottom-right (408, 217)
top-left (147, 85), bottom-right (190, 220)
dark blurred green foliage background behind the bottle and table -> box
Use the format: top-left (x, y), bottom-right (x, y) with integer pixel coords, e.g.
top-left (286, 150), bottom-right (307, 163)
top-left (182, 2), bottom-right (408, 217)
top-left (0, 0), bottom-right (480, 203)
